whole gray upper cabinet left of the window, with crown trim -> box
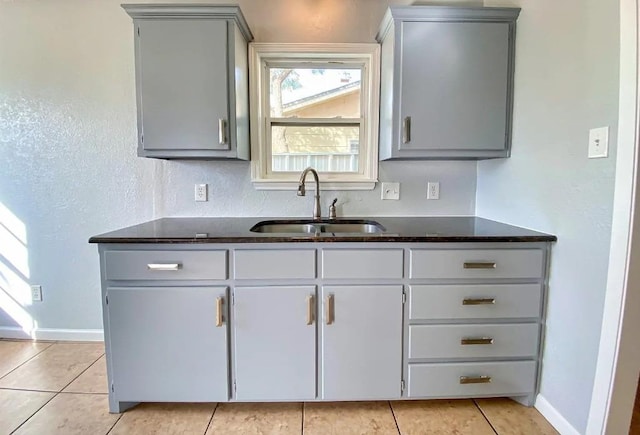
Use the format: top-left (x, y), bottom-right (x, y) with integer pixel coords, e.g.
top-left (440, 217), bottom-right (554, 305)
top-left (123, 5), bottom-right (252, 160)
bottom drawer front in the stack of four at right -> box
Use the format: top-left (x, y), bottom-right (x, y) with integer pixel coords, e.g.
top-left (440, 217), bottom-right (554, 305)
top-left (408, 361), bottom-right (536, 397)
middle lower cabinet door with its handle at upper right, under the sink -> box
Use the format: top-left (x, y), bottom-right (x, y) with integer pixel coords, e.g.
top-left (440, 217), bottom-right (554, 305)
top-left (233, 286), bottom-right (316, 400)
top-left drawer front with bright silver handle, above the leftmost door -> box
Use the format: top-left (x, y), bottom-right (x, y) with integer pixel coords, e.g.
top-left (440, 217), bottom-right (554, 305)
top-left (105, 250), bottom-right (227, 280)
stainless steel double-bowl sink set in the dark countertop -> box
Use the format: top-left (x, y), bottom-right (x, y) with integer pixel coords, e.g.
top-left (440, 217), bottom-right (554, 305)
top-left (251, 220), bottom-right (385, 236)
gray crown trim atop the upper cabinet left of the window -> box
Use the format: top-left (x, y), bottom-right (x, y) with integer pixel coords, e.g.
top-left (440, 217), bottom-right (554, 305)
top-left (121, 3), bottom-right (253, 42)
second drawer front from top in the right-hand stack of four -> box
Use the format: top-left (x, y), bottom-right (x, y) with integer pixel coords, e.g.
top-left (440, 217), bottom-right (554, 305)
top-left (409, 284), bottom-right (542, 320)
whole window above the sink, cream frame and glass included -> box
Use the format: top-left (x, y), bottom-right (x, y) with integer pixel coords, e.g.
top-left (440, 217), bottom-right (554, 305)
top-left (249, 43), bottom-right (379, 190)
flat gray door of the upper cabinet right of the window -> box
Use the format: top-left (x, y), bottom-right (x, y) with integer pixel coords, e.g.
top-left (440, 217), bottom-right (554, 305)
top-left (397, 21), bottom-right (511, 156)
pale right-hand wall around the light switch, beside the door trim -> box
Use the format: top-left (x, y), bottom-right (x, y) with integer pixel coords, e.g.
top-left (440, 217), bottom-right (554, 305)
top-left (476, 0), bottom-right (619, 433)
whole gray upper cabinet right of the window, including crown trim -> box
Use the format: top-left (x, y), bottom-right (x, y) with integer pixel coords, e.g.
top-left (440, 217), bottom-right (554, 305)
top-left (377, 6), bottom-right (520, 160)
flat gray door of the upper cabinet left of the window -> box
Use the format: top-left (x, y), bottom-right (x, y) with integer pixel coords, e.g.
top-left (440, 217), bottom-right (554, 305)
top-left (136, 18), bottom-right (229, 151)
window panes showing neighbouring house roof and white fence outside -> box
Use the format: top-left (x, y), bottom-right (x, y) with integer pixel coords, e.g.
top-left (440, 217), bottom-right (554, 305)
top-left (269, 67), bottom-right (362, 172)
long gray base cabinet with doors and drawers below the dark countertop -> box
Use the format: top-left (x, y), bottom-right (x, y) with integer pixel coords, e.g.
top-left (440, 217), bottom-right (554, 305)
top-left (100, 242), bottom-right (549, 412)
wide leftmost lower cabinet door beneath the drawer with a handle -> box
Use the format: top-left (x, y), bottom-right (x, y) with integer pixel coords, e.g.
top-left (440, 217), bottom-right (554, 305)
top-left (107, 287), bottom-right (229, 402)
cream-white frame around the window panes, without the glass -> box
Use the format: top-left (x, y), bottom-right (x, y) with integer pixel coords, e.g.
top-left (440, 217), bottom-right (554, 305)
top-left (249, 43), bottom-right (380, 190)
